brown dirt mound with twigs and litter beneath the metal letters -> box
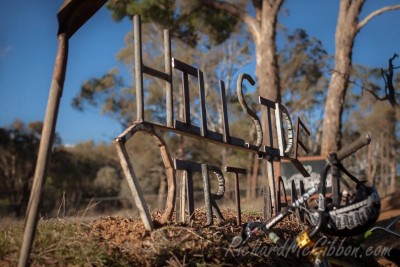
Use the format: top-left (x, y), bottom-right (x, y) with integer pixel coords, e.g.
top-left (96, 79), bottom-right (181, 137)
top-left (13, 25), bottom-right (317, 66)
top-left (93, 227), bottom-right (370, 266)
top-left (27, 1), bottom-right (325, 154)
top-left (86, 192), bottom-right (400, 266)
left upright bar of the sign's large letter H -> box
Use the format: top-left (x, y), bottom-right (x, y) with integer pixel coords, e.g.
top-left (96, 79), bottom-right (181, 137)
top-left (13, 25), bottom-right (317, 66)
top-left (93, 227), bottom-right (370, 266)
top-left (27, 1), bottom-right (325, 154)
top-left (133, 15), bottom-right (144, 121)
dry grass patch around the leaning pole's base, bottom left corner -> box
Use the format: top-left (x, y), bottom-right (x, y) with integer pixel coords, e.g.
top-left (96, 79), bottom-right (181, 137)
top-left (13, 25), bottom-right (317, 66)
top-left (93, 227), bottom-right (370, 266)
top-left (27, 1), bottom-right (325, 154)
top-left (0, 219), bottom-right (128, 266)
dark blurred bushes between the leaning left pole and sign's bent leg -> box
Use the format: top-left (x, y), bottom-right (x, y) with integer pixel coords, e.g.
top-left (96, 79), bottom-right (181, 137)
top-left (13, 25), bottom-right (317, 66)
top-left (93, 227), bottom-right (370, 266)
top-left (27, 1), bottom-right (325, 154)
top-left (44, 141), bottom-right (122, 214)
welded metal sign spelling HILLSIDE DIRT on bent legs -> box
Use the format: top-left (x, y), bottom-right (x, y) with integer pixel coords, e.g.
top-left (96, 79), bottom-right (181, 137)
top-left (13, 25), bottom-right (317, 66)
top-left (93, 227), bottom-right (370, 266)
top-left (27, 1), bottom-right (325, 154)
top-left (114, 15), bottom-right (309, 230)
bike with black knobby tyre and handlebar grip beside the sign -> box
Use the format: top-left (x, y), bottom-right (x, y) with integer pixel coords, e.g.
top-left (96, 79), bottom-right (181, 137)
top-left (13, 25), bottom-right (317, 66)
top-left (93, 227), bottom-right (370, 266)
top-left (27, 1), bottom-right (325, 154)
top-left (231, 134), bottom-right (390, 266)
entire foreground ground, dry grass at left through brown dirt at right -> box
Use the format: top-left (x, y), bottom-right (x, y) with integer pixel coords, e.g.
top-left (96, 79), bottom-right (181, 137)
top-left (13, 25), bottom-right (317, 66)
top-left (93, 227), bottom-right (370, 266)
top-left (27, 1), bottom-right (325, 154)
top-left (0, 192), bottom-right (400, 267)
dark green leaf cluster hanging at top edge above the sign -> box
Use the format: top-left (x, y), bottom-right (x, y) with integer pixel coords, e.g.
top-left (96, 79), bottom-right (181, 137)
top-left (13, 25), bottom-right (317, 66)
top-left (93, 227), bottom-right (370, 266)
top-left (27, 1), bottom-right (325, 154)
top-left (107, 0), bottom-right (239, 47)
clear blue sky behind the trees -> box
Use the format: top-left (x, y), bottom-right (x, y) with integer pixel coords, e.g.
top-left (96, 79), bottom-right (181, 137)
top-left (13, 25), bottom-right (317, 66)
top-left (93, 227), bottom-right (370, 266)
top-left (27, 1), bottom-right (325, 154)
top-left (0, 0), bottom-right (400, 144)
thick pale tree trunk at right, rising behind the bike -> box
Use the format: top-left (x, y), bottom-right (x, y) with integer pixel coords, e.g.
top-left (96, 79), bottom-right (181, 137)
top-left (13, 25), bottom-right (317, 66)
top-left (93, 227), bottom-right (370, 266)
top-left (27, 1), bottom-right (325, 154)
top-left (321, 0), bottom-right (364, 155)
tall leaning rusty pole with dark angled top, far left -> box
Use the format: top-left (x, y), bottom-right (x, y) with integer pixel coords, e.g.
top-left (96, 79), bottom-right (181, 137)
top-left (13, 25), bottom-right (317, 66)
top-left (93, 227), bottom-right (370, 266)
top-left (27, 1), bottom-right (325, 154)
top-left (18, 0), bottom-right (106, 267)
